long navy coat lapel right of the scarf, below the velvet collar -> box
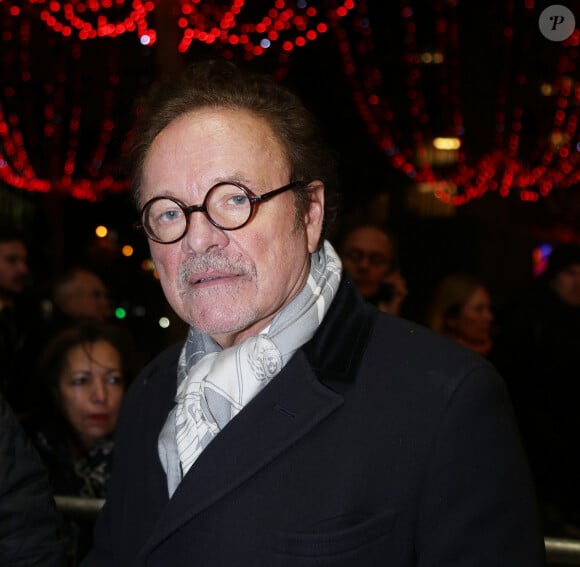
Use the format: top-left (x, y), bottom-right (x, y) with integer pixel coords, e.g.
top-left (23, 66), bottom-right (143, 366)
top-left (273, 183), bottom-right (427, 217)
top-left (142, 352), bottom-right (343, 556)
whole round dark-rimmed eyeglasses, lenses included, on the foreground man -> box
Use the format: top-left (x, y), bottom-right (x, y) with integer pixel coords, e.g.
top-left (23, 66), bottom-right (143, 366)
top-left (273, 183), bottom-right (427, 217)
top-left (135, 181), bottom-right (306, 244)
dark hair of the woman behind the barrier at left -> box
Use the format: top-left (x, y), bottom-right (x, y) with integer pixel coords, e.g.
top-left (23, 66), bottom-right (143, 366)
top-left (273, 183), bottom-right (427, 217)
top-left (34, 322), bottom-right (129, 418)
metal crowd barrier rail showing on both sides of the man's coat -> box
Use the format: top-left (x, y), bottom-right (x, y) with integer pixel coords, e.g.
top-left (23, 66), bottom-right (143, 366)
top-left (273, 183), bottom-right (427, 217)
top-left (54, 496), bottom-right (580, 566)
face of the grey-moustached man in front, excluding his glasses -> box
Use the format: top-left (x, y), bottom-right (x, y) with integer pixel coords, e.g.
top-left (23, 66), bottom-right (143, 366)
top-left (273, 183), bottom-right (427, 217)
top-left (141, 108), bottom-right (324, 347)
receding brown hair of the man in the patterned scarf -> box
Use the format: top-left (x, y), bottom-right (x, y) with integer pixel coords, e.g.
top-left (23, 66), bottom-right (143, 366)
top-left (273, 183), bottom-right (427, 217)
top-left (129, 60), bottom-right (337, 246)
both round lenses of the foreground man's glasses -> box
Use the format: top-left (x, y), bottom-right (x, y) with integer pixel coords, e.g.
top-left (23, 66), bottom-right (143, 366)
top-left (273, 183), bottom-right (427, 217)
top-left (143, 183), bottom-right (252, 242)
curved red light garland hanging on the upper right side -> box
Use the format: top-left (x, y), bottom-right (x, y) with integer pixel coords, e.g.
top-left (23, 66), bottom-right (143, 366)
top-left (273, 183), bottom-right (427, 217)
top-left (333, 0), bottom-right (580, 205)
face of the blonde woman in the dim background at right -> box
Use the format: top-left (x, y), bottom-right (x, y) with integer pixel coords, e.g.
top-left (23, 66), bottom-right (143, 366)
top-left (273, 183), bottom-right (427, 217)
top-left (448, 287), bottom-right (493, 345)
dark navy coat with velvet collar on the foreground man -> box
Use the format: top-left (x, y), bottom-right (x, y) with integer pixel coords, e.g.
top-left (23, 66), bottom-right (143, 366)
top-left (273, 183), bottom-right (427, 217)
top-left (83, 278), bottom-right (543, 567)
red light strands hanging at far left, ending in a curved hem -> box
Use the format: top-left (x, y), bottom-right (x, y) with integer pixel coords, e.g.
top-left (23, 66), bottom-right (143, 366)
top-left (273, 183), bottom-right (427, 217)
top-left (0, 5), bottom-right (133, 201)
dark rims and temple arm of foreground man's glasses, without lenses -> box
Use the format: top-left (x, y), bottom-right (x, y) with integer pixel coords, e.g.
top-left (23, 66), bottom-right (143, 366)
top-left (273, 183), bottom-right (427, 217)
top-left (133, 181), bottom-right (308, 244)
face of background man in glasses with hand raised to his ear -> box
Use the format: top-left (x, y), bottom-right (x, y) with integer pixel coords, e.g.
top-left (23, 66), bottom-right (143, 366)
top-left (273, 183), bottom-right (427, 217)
top-left (342, 227), bottom-right (394, 299)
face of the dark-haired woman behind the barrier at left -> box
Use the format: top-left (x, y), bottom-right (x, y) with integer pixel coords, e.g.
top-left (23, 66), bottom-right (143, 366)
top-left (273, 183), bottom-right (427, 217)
top-left (58, 340), bottom-right (124, 447)
